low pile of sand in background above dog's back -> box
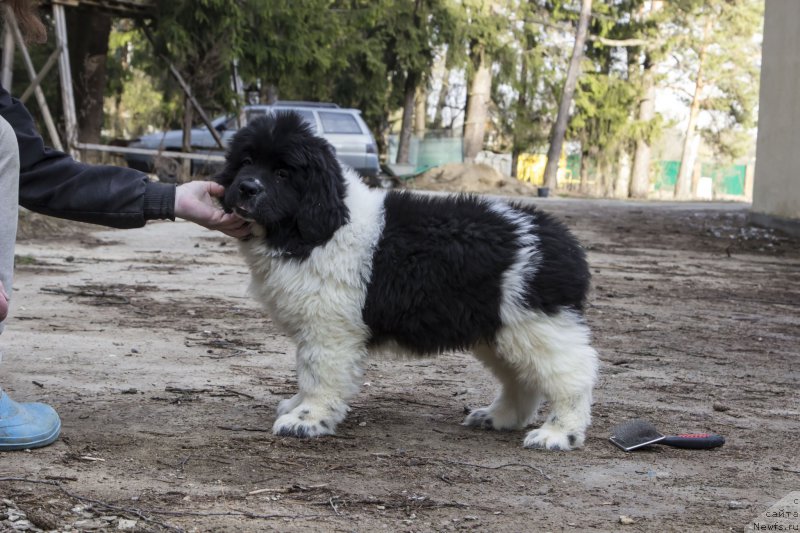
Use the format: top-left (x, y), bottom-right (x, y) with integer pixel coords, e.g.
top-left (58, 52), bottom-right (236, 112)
top-left (405, 163), bottom-right (536, 196)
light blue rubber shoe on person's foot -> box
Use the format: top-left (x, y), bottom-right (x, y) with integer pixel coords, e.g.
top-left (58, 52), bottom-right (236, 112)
top-left (0, 389), bottom-right (61, 452)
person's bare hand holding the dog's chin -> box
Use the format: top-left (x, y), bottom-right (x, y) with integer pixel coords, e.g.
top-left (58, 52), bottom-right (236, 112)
top-left (175, 181), bottom-right (250, 239)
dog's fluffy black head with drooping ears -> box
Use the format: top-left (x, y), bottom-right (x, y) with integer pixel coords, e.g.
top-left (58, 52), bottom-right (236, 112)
top-left (214, 112), bottom-right (349, 257)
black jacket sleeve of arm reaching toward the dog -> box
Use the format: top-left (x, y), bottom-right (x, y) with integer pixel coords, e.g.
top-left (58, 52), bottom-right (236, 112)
top-left (0, 82), bottom-right (175, 228)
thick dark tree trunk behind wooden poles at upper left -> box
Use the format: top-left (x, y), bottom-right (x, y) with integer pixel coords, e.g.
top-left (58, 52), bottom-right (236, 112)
top-left (65, 8), bottom-right (111, 156)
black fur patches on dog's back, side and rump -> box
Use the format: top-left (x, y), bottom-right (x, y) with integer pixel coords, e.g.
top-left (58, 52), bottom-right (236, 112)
top-left (363, 192), bottom-right (589, 353)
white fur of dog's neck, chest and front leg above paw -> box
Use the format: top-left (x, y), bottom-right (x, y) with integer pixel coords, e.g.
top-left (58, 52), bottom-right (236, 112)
top-left (241, 169), bottom-right (386, 408)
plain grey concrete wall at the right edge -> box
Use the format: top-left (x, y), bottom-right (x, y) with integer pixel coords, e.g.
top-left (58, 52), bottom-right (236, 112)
top-left (752, 0), bottom-right (800, 227)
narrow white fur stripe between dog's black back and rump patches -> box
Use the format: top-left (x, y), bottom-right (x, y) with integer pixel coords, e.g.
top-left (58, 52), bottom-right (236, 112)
top-left (489, 201), bottom-right (541, 324)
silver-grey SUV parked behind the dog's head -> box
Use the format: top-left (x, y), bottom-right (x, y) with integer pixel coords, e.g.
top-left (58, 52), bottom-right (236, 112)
top-left (125, 101), bottom-right (380, 181)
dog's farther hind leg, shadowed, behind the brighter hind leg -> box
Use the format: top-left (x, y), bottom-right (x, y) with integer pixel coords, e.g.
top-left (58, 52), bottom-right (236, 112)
top-left (463, 344), bottom-right (541, 430)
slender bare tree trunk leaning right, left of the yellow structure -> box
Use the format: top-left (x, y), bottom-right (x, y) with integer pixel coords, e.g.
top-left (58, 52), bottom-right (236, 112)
top-left (544, 0), bottom-right (592, 190)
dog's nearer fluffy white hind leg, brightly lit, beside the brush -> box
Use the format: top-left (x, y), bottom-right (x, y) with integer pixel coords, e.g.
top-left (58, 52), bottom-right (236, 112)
top-left (497, 310), bottom-right (598, 450)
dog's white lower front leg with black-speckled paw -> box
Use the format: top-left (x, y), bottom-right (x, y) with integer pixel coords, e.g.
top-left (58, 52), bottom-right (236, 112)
top-left (272, 339), bottom-right (366, 437)
